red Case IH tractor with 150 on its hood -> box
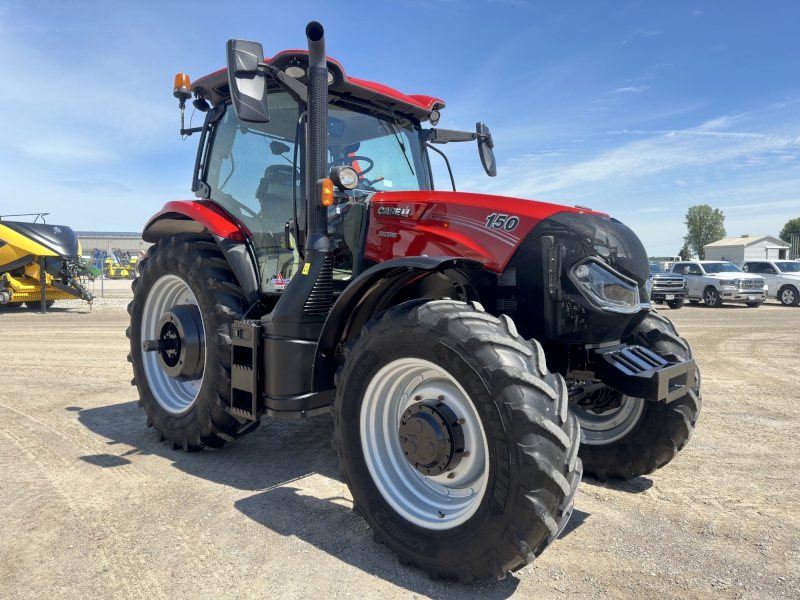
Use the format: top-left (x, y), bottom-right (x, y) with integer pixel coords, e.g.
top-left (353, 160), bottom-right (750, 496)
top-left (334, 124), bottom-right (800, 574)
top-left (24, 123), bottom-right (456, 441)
top-left (128, 22), bottom-right (701, 582)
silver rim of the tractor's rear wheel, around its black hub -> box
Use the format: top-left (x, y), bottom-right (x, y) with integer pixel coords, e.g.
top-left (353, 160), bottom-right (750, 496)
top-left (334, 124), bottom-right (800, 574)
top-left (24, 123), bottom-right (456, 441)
top-left (144, 275), bottom-right (205, 415)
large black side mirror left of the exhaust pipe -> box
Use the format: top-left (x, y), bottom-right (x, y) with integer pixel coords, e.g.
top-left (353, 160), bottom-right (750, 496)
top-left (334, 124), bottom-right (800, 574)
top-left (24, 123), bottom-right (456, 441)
top-left (225, 40), bottom-right (269, 123)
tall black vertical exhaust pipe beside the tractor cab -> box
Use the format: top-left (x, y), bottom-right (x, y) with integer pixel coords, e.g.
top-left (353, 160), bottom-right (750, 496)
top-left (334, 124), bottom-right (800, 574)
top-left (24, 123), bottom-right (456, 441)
top-left (306, 21), bottom-right (331, 252)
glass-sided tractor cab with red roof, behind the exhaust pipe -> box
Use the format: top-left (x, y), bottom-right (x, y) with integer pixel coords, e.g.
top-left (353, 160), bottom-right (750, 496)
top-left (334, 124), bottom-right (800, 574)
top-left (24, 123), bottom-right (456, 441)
top-left (156, 47), bottom-right (494, 305)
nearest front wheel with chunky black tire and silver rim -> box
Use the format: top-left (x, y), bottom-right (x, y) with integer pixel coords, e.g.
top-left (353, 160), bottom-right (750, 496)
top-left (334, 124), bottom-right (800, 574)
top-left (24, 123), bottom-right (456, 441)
top-left (331, 300), bottom-right (582, 583)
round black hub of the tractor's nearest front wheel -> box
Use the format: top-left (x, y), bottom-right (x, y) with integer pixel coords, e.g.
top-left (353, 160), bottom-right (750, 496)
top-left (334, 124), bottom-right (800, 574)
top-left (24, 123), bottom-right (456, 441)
top-left (399, 402), bottom-right (464, 475)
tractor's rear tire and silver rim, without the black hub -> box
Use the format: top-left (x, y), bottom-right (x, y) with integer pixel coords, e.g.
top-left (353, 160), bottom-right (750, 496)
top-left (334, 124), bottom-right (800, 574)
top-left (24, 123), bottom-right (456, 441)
top-left (126, 235), bottom-right (259, 452)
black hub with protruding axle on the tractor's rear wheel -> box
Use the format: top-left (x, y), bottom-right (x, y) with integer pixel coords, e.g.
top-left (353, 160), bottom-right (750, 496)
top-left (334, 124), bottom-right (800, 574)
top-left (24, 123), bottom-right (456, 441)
top-left (142, 304), bottom-right (205, 381)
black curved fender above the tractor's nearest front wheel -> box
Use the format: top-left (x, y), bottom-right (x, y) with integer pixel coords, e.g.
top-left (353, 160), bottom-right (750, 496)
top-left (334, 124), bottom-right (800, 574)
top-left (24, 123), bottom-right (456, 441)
top-left (313, 256), bottom-right (483, 392)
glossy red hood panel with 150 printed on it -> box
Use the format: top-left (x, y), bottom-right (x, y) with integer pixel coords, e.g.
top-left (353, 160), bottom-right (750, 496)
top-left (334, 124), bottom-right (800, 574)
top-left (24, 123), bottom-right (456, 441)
top-left (366, 191), bottom-right (607, 272)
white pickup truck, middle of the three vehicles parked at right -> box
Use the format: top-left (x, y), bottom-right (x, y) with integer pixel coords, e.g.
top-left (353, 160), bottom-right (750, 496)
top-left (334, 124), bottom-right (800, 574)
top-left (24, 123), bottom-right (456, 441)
top-left (672, 260), bottom-right (767, 308)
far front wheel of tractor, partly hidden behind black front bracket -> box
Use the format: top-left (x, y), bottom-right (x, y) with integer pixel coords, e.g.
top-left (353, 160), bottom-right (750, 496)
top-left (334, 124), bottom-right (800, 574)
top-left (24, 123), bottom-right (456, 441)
top-left (572, 313), bottom-right (702, 481)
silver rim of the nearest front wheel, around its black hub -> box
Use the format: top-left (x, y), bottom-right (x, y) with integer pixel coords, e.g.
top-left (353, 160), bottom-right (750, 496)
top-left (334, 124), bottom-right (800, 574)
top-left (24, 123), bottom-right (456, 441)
top-left (360, 358), bottom-right (489, 530)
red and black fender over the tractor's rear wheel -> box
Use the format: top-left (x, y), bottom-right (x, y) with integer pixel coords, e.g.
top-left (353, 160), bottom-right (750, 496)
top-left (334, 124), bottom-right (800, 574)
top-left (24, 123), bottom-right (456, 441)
top-left (142, 200), bottom-right (261, 306)
